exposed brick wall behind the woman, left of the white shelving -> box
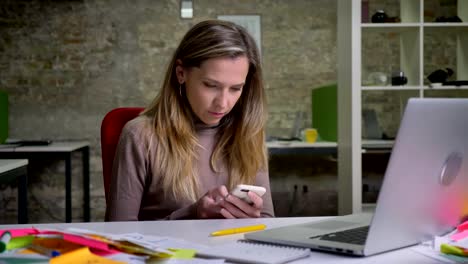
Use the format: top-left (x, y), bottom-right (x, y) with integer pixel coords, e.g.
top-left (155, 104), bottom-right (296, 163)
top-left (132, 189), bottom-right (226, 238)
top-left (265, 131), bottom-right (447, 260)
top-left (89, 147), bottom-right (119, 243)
top-left (0, 0), bottom-right (336, 223)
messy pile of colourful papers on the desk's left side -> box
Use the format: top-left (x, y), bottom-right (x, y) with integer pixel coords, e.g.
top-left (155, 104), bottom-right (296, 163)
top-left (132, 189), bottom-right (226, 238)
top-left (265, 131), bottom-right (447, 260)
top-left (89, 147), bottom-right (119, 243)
top-left (0, 228), bottom-right (208, 264)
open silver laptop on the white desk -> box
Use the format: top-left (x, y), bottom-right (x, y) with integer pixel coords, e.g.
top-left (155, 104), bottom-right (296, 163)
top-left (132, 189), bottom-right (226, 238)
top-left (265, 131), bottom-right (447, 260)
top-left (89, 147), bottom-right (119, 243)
top-left (244, 98), bottom-right (468, 256)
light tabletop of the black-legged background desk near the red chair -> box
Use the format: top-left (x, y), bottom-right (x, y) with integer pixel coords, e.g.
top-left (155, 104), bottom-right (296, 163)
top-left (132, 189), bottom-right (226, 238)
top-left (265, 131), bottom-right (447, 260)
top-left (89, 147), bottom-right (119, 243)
top-left (0, 141), bottom-right (89, 152)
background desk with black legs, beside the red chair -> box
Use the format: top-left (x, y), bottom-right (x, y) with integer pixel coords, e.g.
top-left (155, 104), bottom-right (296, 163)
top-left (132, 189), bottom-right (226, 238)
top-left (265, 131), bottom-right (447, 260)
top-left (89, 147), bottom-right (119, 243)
top-left (0, 141), bottom-right (90, 223)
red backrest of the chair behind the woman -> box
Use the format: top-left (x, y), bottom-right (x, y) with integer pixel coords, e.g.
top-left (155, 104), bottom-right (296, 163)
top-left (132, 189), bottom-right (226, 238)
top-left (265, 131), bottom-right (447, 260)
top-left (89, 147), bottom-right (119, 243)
top-left (101, 107), bottom-right (144, 204)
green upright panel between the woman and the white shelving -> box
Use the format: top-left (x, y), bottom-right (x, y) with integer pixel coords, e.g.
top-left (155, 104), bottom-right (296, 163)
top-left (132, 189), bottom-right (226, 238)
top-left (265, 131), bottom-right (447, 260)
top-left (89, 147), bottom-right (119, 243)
top-left (312, 84), bottom-right (338, 142)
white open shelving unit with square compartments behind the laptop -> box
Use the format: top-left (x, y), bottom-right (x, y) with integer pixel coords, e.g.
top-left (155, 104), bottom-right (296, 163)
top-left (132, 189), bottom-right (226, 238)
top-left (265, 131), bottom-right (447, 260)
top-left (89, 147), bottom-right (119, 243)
top-left (337, 0), bottom-right (468, 214)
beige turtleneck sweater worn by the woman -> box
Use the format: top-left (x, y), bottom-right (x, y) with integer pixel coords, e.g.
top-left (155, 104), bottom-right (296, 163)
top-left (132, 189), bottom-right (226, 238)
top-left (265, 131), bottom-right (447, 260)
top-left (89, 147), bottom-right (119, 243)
top-left (106, 116), bottom-right (274, 221)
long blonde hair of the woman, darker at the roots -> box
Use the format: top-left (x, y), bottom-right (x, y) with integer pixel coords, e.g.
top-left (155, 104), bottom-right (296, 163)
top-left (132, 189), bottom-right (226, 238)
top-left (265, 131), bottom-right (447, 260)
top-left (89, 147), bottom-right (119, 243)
top-left (142, 20), bottom-right (268, 201)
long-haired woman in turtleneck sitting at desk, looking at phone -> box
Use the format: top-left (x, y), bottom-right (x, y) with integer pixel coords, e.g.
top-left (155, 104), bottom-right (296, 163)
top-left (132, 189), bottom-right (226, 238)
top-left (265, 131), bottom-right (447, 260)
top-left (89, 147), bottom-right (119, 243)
top-left (106, 20), bottom-right (274, 221)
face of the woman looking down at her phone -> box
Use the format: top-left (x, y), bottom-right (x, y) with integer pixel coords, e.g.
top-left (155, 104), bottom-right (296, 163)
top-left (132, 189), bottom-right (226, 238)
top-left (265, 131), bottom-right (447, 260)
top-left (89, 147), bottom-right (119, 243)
top-left (176, 56), bottom-right (249, 125)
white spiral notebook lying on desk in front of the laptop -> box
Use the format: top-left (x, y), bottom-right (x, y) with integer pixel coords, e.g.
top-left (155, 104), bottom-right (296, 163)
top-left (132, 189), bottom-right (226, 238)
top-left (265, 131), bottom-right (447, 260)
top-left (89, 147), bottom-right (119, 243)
top-left (197, 240), bottom-right (310, 264)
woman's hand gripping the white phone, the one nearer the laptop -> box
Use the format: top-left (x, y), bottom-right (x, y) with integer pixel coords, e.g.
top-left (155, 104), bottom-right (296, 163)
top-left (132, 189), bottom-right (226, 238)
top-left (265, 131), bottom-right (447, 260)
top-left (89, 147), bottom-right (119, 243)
top-left (220, 191), bottom-right (263, 218)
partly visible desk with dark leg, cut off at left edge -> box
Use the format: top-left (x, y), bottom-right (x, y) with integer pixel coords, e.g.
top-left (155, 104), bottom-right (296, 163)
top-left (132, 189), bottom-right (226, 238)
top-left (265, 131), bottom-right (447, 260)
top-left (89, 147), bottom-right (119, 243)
top-left (0, 159), bottom-right (28, 224)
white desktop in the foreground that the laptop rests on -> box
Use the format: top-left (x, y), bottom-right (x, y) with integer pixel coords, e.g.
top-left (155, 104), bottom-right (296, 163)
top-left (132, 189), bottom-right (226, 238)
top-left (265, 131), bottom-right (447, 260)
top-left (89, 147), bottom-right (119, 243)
top-left (0, 217), bottom-right (439, 264)
